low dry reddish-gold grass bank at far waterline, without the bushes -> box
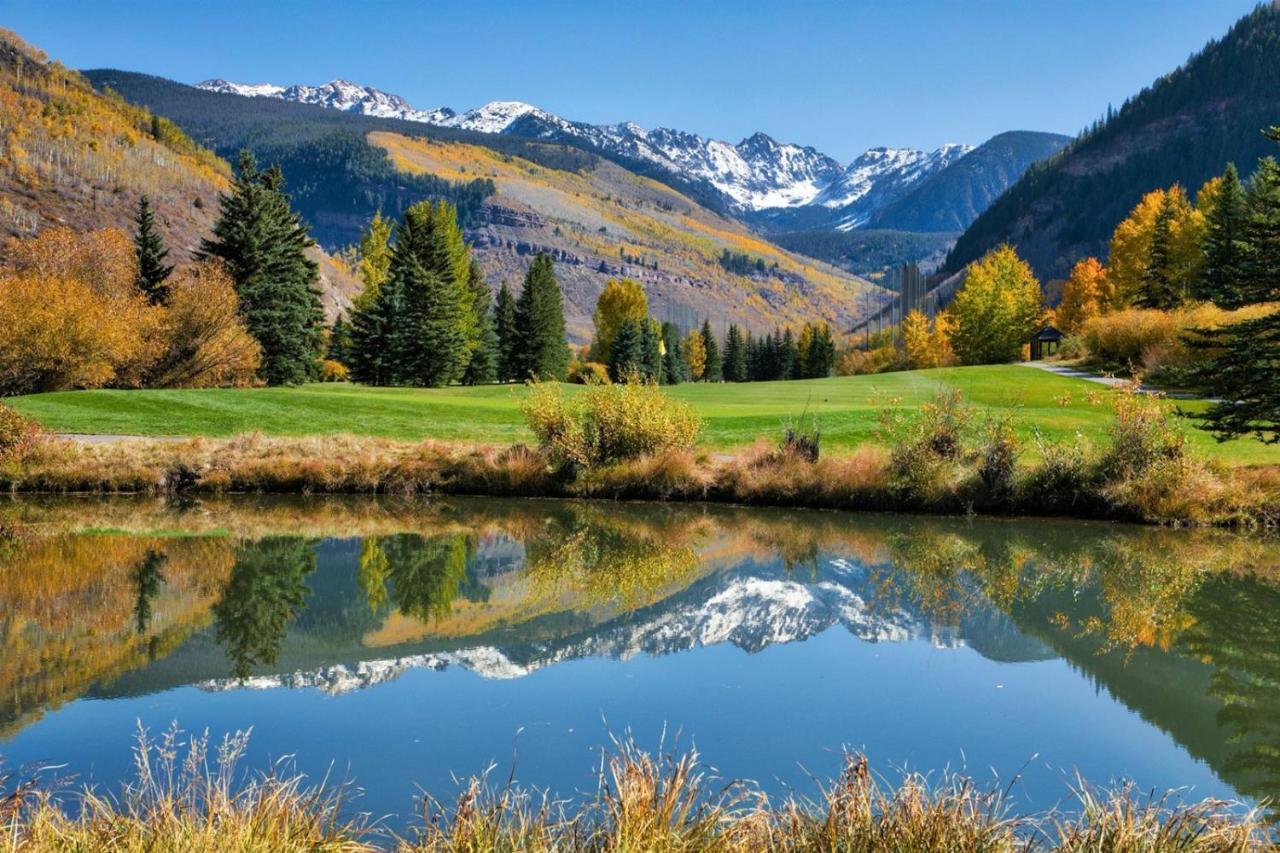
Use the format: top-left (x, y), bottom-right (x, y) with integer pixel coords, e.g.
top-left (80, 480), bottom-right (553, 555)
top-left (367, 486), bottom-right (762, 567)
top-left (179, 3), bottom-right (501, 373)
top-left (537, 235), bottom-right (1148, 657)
top-left (0, 434), bottom-right (1280, 529)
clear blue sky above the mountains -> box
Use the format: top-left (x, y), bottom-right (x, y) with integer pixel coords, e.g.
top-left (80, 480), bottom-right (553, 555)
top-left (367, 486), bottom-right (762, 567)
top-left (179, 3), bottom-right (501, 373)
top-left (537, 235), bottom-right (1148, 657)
top-left (0, 0), bottom-right (1254, 160)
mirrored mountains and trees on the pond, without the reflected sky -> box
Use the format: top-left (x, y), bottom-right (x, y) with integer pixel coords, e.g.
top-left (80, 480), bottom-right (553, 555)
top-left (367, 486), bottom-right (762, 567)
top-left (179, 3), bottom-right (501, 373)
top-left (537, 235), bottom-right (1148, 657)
top-left (0, 500), bottom-right (1280, 798)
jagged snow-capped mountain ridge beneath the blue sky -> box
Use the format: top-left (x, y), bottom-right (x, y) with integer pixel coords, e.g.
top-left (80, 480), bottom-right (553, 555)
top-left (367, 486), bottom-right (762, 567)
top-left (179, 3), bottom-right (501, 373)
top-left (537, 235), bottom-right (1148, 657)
top-left (196, 78), bottom-right (973, 216)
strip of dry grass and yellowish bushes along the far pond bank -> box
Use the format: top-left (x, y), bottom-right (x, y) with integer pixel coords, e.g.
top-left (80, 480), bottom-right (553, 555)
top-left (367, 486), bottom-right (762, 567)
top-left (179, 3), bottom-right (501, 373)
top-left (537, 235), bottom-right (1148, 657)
top-left (0, 382), bottom-right (1280, 528)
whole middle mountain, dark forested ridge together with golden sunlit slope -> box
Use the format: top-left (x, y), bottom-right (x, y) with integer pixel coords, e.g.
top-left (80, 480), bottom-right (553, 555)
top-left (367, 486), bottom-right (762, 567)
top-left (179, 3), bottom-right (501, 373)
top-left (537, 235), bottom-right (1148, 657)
top-left (87, 70), bottom-right (883, 339)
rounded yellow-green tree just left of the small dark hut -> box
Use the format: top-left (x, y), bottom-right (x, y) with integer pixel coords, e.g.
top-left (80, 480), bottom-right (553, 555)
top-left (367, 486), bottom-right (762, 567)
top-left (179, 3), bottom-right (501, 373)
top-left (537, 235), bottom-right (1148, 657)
top-left (950, 245), bottom-right (1042, 364)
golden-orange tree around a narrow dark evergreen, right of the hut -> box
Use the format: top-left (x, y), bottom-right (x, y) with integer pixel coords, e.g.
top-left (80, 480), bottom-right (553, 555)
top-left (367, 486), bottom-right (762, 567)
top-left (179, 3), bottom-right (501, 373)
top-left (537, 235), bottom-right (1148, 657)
top-left (1107, 184), bottom-right (1212, 309)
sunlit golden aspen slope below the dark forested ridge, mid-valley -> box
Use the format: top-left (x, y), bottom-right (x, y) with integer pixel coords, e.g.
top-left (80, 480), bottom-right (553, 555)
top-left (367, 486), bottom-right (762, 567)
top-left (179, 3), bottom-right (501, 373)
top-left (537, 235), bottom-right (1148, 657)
top-left (369, 132), bottom-right (884, 341)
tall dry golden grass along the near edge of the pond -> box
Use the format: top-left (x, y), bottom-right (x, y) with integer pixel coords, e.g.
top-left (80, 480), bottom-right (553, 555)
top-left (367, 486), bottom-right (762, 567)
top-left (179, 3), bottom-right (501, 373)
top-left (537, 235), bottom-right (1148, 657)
top-left (0, 729), bottom-right (1280, 853)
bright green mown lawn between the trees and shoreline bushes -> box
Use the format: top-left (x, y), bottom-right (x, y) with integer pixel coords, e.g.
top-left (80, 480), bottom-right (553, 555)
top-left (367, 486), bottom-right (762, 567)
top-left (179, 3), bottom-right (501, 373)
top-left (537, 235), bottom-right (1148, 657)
top-left (6, 365), bottom-right (1280, 464)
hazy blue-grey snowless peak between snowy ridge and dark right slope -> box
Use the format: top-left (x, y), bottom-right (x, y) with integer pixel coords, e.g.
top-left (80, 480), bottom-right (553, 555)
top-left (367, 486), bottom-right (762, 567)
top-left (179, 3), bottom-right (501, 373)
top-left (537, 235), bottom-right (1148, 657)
top-left (868, 131), bottom-right (1071, 232)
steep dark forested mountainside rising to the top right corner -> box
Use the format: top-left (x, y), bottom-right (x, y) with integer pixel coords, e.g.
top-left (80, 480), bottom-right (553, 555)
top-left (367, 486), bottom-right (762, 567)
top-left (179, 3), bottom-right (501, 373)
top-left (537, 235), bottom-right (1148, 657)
top-left (946, 4), bottom-right (1280, 278)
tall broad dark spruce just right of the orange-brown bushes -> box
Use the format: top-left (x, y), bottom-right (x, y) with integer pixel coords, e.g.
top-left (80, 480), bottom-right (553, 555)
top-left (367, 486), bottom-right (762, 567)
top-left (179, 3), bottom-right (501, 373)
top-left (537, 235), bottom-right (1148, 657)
top-left (200, 151), bottom-right (324, 384)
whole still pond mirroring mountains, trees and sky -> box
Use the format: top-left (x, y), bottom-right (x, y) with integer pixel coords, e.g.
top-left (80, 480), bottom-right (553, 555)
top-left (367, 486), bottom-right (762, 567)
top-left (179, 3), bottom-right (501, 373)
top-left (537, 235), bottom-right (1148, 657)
top-left (0, 498), bottom-right (1280, 824)
